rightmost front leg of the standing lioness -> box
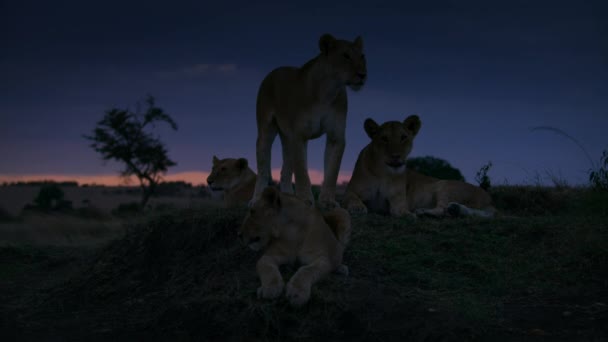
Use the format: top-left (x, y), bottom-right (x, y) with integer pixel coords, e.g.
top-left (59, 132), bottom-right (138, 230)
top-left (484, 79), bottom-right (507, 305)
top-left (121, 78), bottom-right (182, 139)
top-left (318, 120), bottom-right (346, 209)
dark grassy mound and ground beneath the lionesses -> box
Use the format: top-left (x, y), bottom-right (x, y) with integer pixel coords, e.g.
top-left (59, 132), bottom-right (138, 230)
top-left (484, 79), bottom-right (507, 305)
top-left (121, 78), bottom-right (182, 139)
top-left (0, 186), bottom-right (608, 341)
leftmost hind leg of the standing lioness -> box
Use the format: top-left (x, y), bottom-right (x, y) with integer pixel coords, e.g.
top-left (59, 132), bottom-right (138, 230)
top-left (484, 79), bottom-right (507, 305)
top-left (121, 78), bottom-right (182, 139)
top-left (249, 121), bottom-right (278, 206)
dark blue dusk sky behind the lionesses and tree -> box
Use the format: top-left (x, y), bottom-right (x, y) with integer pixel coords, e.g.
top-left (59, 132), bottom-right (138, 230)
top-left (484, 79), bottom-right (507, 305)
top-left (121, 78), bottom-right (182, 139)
top-left (0, 0), bottom-right (608, 184)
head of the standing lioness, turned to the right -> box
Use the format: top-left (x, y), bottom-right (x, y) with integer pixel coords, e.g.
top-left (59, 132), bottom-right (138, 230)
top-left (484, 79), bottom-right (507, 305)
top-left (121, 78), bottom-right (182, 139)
top-left (319, 34), bottom-right (367, 91)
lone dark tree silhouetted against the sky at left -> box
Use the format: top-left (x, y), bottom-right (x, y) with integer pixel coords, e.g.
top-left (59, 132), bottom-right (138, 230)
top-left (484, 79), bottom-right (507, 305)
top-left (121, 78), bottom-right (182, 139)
top-left (84, 95), bottom-right (177, 208)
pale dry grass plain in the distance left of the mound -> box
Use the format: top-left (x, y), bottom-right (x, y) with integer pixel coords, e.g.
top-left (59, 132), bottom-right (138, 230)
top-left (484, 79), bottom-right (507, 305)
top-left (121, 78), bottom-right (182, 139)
top-left (0, 186), bottom-right (222, 246)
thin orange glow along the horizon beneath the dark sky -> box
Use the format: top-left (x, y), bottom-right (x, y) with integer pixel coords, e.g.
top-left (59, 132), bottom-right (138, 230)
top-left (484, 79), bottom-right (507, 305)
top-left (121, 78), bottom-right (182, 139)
top-left (0, 169), bottom-right (351, 186)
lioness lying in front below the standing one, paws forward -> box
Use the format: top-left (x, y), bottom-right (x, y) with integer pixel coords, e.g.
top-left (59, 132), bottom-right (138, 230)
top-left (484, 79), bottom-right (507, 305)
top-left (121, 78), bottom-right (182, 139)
top-left (238, 187), bottom-right (351, 306)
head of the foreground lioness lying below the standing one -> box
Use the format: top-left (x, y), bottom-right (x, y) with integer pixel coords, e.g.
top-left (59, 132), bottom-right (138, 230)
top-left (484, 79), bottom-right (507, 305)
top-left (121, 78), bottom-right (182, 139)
top-left (238, 188), bottom-right (281, 251)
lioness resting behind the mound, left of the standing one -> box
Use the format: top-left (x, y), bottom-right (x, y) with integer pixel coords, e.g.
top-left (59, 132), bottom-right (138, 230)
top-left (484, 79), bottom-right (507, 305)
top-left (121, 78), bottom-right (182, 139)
top-left (207, 156), bottom-right (257, 207)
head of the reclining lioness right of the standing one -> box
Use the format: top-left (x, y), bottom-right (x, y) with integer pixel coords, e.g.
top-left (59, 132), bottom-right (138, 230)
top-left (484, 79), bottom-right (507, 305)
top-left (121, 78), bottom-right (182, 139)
top-left (364, 115), bottom-right (421, 174)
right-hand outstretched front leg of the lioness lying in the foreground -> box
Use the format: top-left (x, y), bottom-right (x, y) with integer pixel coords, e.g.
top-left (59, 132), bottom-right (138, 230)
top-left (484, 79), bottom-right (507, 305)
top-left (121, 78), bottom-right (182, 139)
top-left (285, 257), bottom-right (331, 306)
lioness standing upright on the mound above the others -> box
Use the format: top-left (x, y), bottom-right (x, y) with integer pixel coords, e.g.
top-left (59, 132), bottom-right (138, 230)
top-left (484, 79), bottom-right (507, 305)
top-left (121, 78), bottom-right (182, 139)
top-left (250, 34), bottom-right (367, 208)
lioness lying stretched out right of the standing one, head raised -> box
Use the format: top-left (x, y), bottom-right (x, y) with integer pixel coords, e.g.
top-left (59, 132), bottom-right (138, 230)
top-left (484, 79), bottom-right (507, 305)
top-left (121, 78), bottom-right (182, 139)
top-left (344, 115), bottom-right (496, 217)
